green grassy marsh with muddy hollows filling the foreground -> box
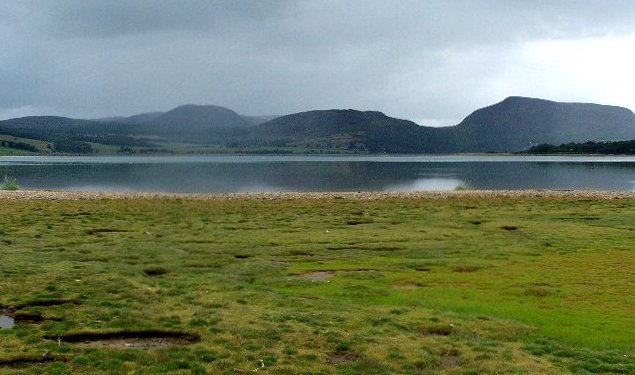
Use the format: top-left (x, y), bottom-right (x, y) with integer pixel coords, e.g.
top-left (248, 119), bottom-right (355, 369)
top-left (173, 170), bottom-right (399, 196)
top-left (0, 194), bottom-right (635, 375)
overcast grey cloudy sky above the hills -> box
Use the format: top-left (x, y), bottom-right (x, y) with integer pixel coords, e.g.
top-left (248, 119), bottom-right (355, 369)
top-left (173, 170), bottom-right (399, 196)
top-left (0, 0), bottom-right (635, 126)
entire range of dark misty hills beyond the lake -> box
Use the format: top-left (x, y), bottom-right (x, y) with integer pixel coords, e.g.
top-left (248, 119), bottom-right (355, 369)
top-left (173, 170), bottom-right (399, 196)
top-left (0, 97), bottom-right (635, 153)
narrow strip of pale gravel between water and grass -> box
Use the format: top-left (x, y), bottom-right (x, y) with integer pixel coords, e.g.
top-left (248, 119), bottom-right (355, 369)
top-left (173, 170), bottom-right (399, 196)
top-left (0, 190), bottom-right (635, 200)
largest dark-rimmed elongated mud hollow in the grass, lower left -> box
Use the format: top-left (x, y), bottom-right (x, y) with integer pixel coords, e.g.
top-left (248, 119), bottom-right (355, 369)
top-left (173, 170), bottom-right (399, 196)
top-left (44, 330), bottom-right (201, 349)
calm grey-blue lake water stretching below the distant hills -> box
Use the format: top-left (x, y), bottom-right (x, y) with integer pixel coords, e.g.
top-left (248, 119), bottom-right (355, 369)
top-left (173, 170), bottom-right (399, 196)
top-left (0, 155), bottom-right (635, 192)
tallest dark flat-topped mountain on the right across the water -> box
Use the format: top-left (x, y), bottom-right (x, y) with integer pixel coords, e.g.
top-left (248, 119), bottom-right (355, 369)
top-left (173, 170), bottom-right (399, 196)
top-left (442, 96), bottom-right (635, 152)
